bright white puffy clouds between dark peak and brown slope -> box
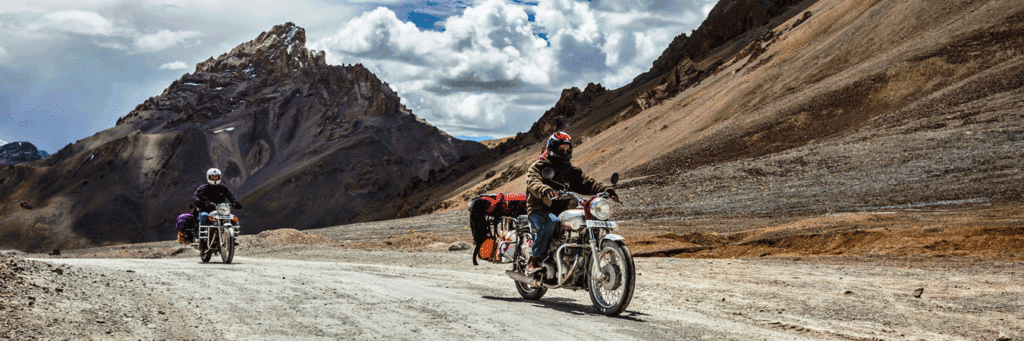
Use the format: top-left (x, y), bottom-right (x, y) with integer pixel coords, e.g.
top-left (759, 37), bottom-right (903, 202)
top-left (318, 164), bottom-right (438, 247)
top-left (310, 0), bottom-right (716, 135)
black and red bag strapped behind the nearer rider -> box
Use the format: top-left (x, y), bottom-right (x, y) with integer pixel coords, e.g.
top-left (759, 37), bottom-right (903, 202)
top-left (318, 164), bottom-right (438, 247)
top-left (469, 194), bottom-right (526, 265)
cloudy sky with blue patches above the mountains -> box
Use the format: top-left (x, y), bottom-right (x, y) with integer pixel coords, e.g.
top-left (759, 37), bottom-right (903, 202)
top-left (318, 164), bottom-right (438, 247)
top-left (0, 0), bottom-right (717, 153)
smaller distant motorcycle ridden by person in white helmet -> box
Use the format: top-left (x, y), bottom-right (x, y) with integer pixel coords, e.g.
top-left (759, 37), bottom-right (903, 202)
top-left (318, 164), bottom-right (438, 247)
top-left (196, 203), bottom-right (241, 264)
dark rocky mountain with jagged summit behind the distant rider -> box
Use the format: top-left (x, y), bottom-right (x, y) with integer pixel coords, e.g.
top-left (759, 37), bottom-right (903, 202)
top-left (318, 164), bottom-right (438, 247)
top-left (0, 23), bottom-right (485, 250)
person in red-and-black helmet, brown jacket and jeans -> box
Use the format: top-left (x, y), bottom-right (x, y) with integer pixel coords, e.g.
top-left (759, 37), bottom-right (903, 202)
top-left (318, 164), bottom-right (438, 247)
top-left (526, 131), bottom-right (618, 273)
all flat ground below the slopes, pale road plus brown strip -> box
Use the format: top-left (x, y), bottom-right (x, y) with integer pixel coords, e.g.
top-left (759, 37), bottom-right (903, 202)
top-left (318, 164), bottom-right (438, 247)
top-left (0, 202), bottom-right (1024, 340)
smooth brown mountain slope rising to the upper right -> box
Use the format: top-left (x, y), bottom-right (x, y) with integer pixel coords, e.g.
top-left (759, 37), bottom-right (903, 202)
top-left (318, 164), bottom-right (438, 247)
top-left (376, 0), bottom-right (1024, 220)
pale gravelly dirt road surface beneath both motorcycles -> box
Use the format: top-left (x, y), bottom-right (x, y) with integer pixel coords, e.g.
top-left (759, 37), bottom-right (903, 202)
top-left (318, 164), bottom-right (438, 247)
top-left (6, 246), bottom-right (1024, 340)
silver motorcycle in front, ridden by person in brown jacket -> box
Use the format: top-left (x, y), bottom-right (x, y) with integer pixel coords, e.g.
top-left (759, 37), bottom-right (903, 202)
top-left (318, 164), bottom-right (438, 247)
top-left (494, 168), bottom-right (636, 315)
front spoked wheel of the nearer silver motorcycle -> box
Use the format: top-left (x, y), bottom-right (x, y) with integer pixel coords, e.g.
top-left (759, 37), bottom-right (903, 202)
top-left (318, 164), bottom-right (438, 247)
top-left (590, 241), bottom-right (636, 316)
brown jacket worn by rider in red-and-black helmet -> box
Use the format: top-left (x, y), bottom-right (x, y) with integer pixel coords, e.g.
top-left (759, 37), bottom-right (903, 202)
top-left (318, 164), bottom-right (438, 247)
top-left (526, 159), bottom-right (611, 214)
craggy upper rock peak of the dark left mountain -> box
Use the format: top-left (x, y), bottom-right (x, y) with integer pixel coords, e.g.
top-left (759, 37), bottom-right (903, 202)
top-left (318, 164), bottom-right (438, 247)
top-left (118, 23), bottom-right (410, 133)
